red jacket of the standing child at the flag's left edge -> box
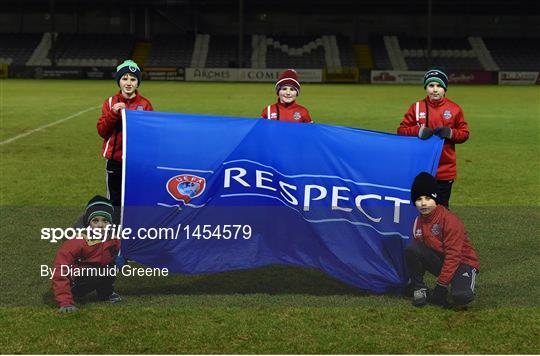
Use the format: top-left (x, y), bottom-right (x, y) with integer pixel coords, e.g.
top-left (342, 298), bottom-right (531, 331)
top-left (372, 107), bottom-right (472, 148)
top-left (97, 91), bottom-right (154, 161)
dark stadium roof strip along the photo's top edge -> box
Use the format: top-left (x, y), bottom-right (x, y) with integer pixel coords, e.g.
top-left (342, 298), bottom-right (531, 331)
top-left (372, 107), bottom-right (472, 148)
top-left (2, 0), bottom-right (540, 16)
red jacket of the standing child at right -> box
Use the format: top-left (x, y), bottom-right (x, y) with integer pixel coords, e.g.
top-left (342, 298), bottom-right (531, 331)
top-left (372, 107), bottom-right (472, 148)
top-left (397, 97), bottom-right (469, 180)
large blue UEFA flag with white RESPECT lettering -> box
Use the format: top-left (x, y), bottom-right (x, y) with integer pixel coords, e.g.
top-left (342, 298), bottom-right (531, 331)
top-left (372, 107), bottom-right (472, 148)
top-left (122, 110), bottom-right (443, 293)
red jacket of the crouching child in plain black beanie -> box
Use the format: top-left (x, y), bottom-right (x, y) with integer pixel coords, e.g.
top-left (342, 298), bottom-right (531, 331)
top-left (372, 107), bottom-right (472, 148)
top-left (413, 205), bottom-right (480, 285)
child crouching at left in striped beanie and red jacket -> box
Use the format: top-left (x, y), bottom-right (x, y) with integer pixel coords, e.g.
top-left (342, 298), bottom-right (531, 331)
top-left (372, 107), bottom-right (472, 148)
top-left (52, 196), bottom-right (121, 313)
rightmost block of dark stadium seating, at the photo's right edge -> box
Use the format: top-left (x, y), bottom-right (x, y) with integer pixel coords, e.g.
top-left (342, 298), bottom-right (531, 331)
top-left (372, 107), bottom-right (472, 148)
top-left (484, 38), bottom-right (540, 71)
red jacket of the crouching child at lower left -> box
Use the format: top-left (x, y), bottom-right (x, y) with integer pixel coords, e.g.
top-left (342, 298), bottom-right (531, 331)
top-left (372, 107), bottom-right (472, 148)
top-left (52, 238), bottom-right (120, 307)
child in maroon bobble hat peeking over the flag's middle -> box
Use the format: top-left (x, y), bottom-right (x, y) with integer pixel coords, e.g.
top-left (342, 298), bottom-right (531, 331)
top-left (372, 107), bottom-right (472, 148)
top-left (262, 69), bottom-right (313, 124)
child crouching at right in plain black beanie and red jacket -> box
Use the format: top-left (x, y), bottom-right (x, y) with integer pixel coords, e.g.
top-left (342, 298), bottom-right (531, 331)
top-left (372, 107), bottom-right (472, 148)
top-left (405, 172), bottom-right (479, 307)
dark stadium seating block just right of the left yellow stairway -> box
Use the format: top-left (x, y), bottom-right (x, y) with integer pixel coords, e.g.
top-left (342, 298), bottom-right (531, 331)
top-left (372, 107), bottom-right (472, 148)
top-left (146, 35), bottom-right (195, 67)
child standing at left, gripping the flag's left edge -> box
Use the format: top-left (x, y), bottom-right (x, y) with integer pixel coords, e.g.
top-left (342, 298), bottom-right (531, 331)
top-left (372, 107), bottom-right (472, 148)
top-left (97, 60), bottom-right (154, 214)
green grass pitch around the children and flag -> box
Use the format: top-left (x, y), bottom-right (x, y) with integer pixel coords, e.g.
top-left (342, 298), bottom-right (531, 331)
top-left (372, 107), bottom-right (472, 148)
top-left (0, 80), bottom-right (540, 353)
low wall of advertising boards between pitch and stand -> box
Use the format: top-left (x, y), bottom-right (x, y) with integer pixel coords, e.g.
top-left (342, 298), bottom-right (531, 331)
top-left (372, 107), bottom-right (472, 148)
top-left (5, 64), bottom-right (540, 85)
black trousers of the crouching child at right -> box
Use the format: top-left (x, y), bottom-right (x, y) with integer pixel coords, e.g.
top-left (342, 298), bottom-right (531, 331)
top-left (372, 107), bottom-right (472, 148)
top-left (405, 241), bottom-right (477, 305)
